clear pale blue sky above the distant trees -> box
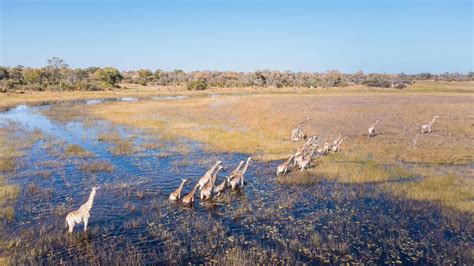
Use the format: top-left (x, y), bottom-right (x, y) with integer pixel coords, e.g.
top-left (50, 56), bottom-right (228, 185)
top-left (0, 0), bottom-right (474, 73)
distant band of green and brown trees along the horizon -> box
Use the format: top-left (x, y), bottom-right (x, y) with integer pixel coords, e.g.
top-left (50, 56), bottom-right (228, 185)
top-left (0, 57), bottom-right (474, 92)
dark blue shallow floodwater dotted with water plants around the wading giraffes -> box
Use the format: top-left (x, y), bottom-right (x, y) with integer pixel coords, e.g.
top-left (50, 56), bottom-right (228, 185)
top-left (0, 98), bottom-right (474, 264)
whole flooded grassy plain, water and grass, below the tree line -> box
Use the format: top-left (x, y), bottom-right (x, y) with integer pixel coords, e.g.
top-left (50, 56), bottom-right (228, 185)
top-left (0, 81), bottom-right (474, 265)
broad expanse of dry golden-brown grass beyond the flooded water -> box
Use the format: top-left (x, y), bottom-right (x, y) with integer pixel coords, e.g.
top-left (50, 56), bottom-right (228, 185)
top-left (87, 80), bottom-right (474, 163)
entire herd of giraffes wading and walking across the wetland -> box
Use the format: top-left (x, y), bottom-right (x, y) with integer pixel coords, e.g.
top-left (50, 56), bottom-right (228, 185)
top-left (66, 116), bottom-right (439, 232)
